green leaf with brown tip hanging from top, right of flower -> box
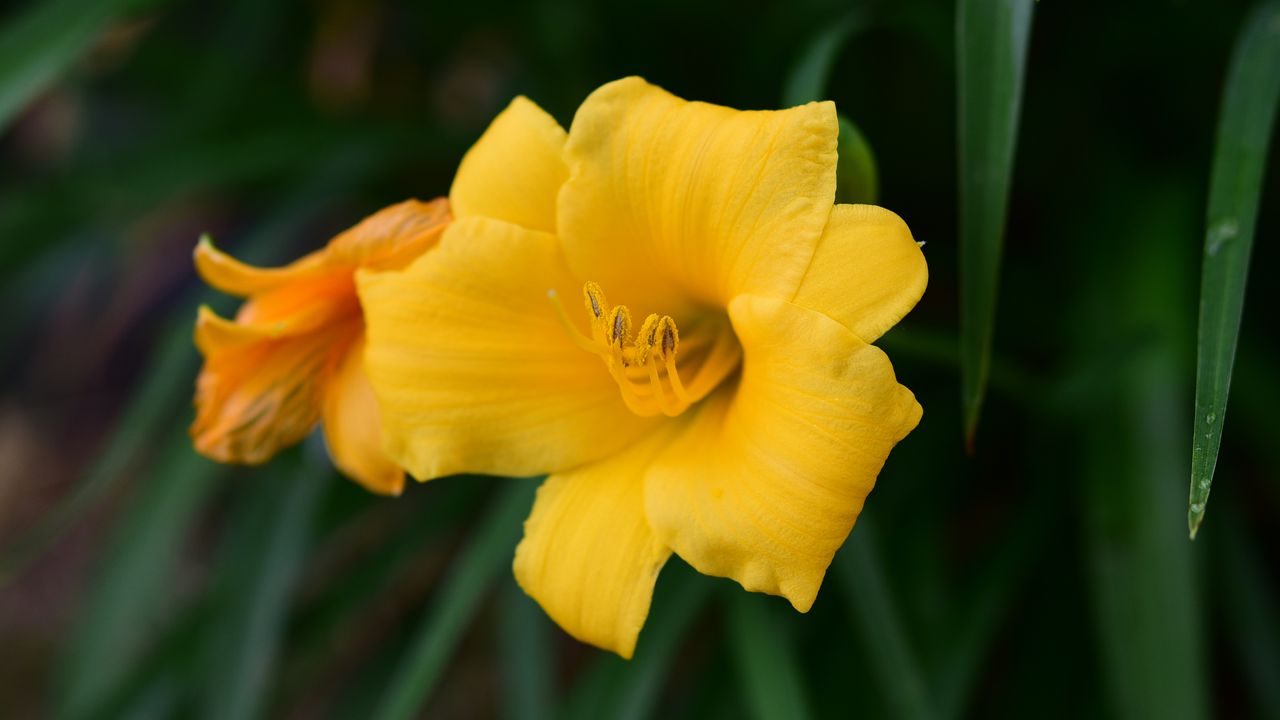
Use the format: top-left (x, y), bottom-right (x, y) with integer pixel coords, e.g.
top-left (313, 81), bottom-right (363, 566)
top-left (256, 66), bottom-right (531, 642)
top-left (956, 0), bottom-right (1033, 448)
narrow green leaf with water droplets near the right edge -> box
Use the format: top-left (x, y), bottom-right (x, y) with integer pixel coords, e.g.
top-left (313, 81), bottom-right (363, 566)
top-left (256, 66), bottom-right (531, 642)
top-left (1187, 1), bottom-right (1280, 538)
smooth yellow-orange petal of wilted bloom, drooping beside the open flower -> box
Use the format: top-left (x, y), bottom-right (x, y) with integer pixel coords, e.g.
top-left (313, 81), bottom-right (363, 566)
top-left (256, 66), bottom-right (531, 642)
top-left (324, 336), bottom-right (404, 495)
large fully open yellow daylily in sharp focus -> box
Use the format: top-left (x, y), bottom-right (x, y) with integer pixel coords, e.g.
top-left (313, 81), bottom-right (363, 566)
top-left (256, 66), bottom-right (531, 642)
top-left (357, 78), bottom-right (928, 657)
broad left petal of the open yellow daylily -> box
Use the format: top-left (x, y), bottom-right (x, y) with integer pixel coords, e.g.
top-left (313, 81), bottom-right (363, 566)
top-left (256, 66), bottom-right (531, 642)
top-left (357, 218), bottom-right (652, 479)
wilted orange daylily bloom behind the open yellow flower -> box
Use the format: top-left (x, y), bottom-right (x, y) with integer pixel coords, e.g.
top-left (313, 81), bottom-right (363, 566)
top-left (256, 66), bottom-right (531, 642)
top-left (191, 199), bottom-right (449, 495)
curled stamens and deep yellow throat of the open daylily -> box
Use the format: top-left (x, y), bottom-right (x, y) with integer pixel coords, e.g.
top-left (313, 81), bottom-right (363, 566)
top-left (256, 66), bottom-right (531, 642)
top-left (547, 282), bottom-right (742, 418)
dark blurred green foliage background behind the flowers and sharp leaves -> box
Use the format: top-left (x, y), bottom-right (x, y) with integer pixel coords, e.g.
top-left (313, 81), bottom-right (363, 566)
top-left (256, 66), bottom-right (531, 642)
top-left (0, 0), bottom-right (1280, 720)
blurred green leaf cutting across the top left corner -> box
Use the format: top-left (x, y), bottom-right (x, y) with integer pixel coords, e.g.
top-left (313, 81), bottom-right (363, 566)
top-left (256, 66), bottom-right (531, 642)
top-left (0, 0), bottom-right (156, 132)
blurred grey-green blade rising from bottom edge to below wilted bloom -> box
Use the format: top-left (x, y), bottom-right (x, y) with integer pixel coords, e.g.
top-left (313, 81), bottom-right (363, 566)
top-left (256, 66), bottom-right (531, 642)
top-left (201, 451), bottom-right (333, 719)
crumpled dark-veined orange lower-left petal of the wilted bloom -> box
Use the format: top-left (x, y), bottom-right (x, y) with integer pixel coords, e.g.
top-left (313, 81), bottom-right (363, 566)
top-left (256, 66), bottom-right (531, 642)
top-left (191, 317), bottom-right (345, 464)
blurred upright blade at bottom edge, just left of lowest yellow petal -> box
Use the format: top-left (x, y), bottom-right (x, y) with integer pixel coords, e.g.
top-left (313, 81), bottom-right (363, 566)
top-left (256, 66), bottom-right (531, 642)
top-left (498, 577), bottom-right (557, 720)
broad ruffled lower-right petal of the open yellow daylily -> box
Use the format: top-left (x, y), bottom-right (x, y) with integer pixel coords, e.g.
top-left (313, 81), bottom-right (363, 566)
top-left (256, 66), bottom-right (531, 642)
top-left (645, 296), bottom-right (920, 612)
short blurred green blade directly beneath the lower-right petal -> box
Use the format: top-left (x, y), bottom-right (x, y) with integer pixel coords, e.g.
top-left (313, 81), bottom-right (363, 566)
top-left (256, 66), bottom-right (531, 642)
top-left (727, 588), bottom-right (810, 720)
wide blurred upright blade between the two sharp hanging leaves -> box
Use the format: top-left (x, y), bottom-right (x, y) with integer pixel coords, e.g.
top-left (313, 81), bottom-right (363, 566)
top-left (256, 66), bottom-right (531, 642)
top-left (1075, 184), bottom-right (1210, 720)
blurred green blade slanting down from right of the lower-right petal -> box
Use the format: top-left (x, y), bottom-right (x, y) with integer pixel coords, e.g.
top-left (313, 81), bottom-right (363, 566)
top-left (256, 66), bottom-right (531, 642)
top-left (833, 516), bottom-right (936, 719)
